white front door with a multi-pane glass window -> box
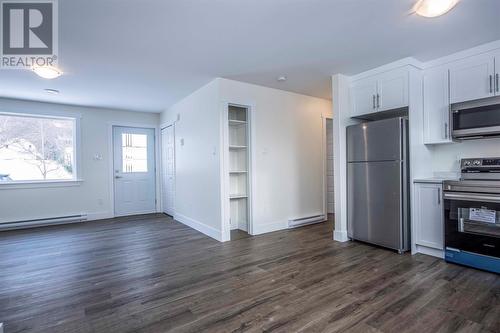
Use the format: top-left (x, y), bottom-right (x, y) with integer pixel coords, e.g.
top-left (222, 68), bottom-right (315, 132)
top-left (113, 126), bottom-right (156, 216)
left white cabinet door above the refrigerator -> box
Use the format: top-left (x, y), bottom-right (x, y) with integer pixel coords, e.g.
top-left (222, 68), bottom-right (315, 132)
top-left (349, 78), bottom-right (377, 117)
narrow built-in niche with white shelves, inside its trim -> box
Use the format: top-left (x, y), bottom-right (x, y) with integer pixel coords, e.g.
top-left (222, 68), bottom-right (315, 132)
top-left (228, 105), bottom-right (250, 232)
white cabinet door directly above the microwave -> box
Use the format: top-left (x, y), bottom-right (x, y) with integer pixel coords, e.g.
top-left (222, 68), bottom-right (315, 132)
top-left (450, 54), bottom-right (495, 103)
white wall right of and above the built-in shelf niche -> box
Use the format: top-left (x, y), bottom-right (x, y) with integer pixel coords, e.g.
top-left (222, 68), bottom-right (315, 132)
top-left (219, 79), bottom-right (332, 234)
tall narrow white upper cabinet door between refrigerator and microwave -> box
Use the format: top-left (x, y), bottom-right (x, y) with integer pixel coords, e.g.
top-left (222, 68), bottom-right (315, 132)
top-left (423, 67), bottom-right (451, 144)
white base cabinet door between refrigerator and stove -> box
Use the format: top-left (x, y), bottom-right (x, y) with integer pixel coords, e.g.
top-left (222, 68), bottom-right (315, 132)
top-left (415, 183), bottom-right (444, 250)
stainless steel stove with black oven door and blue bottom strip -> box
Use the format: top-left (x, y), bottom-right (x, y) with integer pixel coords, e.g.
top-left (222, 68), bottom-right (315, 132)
top-left (443, 158), bottom-right (500, 273)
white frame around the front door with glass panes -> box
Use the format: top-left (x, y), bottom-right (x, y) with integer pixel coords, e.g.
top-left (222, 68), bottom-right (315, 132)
top-left (107, 121), bottom-right (161, 217)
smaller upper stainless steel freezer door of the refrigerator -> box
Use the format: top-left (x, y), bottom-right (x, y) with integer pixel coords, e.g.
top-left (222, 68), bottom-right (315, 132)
top-left (347, 118), bottom-right (404, 162)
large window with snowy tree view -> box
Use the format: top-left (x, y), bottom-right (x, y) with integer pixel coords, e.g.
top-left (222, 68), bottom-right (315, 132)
top-left (0, 113), bottom-right (76, 183)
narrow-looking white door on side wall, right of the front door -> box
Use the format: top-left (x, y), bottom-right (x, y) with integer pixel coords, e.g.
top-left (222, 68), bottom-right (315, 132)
top-left (161, 125), bottom-right (175, 216)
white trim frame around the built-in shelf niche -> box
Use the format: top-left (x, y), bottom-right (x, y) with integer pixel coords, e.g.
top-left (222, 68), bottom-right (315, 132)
top-left (220, 100), bottom-right (256, 242)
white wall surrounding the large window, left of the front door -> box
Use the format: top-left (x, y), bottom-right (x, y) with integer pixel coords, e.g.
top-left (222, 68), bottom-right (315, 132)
top-left (0, 99), bottom-right (159, 222)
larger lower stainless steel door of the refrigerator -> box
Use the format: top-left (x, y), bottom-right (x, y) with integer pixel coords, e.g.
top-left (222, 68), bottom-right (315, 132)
top-left (347, 161), bottom-right (404, 250)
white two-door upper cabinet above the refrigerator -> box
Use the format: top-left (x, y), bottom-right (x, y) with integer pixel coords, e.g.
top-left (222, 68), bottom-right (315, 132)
top-left (349, 69), bottom-right (409, 117)
